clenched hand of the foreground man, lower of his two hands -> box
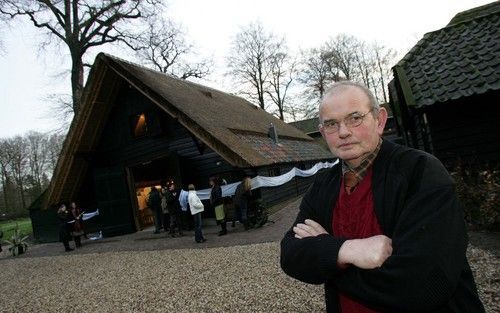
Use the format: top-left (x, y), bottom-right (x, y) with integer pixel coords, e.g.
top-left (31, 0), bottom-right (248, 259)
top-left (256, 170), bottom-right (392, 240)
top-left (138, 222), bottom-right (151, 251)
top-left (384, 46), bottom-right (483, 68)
top-left (337, 235), bottom-right (392, 269)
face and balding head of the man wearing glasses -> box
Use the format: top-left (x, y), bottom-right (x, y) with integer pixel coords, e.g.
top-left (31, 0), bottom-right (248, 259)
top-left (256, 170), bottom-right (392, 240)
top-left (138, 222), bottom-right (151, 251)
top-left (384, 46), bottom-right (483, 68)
top-left (319, 86), bottom-right (387, 167)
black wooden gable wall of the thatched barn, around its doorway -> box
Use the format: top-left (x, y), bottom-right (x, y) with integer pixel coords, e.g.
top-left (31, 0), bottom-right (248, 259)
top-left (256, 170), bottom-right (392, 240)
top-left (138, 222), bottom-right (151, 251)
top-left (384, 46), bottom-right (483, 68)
top-left (78, 87), bottom-right (236, 235)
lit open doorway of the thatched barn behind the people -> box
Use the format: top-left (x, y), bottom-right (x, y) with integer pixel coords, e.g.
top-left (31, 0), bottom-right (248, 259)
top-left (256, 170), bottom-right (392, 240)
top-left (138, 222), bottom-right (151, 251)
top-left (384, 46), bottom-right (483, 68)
top-left (129, 155), bottom-right (180, 230)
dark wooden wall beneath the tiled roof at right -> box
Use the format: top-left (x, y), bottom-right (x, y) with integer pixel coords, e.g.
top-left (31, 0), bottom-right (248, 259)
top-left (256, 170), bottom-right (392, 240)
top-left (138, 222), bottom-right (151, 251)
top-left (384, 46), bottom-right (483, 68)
top-left (427, 92), bottom-right (500, 166)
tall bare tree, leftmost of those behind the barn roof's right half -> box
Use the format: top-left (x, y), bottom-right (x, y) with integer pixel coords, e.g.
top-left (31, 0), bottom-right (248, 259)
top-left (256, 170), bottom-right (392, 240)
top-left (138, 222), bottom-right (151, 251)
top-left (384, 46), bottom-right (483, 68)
top-left (227, 22), bottom-right (284, 109)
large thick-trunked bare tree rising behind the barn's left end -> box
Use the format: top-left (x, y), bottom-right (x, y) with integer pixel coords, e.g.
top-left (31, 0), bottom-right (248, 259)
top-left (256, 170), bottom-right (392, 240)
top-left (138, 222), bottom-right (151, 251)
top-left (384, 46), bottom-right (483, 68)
top-left (0, 0), bottom-right (161, 114)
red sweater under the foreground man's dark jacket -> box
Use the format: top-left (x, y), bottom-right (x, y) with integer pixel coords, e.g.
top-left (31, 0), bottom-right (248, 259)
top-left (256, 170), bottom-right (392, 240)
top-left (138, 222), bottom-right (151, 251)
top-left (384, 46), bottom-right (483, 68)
top-left (332, 168), bottom-right (382, 313)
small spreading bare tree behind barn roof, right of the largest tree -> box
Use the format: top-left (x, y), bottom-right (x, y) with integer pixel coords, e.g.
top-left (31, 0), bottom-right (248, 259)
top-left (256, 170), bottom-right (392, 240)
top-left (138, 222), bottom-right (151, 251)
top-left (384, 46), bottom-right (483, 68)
top-left (127, 19), bottom-right (212, 79)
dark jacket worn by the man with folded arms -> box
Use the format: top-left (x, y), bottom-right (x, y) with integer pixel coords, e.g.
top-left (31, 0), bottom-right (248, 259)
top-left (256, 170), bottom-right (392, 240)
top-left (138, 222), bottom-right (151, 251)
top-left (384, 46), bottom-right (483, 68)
top-left (281, 141), bottom-right (484, 313)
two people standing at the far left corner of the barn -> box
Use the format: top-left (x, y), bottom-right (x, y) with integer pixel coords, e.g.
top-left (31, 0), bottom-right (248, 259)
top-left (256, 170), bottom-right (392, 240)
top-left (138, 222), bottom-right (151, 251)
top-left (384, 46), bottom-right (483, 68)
top-left (57, 202), bottom-right (86, 252)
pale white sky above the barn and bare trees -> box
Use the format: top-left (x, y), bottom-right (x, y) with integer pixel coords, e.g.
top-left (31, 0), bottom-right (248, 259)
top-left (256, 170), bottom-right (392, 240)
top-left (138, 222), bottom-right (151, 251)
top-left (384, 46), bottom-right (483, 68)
top-left (0, 0), bottom-right (492, 138)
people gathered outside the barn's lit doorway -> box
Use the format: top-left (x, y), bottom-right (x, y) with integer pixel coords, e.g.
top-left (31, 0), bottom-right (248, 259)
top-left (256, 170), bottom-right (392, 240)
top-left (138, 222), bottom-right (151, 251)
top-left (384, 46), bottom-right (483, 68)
top-left (148, 177), bottom-right (252, 243)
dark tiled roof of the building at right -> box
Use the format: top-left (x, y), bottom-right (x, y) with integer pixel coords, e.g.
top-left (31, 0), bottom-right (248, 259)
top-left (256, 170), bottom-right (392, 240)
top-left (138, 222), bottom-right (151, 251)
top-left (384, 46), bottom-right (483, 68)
top-left (394, 1), bottom-right (500, 106)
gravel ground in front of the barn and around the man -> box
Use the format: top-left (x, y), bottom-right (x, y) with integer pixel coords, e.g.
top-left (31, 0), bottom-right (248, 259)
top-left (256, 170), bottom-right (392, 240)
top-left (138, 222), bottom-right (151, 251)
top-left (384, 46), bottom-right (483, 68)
top-left (0, 196), bottom-right (500, 313)
